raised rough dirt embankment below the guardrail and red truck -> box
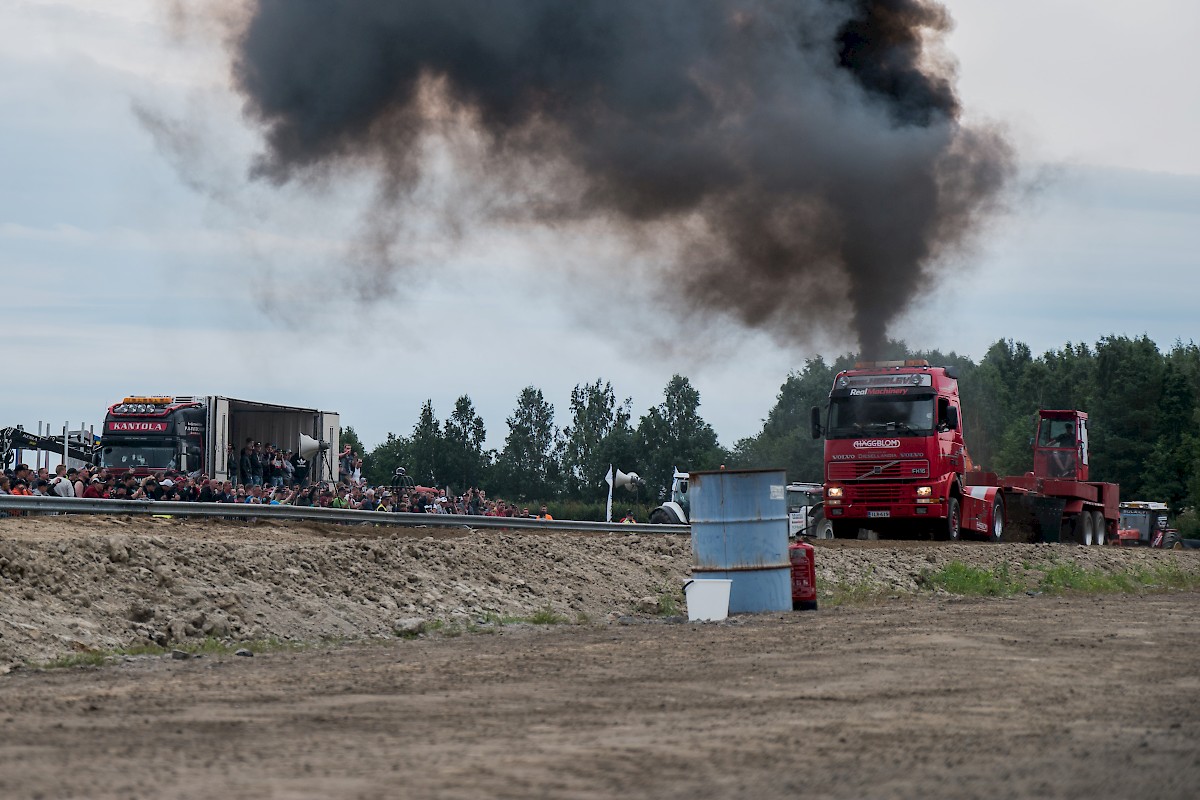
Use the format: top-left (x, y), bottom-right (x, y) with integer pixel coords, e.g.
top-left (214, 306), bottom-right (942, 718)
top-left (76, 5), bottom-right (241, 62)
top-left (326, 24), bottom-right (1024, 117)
top-left (0, 517), bottom-right (1200, 667)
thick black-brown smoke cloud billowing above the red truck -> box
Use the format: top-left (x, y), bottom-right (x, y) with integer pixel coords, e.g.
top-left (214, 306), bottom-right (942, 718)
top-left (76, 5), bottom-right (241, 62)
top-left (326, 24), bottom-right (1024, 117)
top-left (218, 0), bottom-right (1014, 353)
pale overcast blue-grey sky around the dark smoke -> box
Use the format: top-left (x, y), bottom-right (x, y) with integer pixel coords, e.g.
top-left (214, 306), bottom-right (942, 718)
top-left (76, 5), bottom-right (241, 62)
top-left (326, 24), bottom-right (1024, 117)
top-left (0, 0), bottom-right (1200, 447)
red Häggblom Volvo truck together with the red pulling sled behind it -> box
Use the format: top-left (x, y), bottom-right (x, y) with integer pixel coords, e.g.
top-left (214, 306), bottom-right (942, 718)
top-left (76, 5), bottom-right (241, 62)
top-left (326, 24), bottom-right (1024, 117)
top-left (811, 360), bottom-right (1118, 545)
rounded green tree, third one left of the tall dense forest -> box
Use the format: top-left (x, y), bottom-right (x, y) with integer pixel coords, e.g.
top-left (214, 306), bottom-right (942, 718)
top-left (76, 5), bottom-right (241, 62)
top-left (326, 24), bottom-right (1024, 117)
top-left (494, 386), bottom-right (559, 500)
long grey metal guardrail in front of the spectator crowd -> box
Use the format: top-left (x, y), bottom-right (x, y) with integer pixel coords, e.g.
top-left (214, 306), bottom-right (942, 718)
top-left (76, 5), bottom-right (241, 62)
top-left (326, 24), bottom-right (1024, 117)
top-left (0, 494), bottom-right (691, 534)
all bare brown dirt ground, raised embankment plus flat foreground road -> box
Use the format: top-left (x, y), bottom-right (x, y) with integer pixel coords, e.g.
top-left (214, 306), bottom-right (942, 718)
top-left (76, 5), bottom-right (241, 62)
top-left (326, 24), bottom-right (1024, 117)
top-left (0, 517), bottom-right (1200, 800)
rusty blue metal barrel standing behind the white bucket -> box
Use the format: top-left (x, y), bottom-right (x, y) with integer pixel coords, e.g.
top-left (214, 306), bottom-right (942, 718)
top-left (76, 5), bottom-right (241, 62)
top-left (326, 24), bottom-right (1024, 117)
top-left (688, 469), bottom-right (792, 614)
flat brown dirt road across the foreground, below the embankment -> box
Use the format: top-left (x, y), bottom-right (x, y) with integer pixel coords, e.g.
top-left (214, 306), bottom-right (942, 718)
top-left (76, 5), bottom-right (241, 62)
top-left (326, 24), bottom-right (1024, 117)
top-left (0, 593), bottom-right (1200, 799)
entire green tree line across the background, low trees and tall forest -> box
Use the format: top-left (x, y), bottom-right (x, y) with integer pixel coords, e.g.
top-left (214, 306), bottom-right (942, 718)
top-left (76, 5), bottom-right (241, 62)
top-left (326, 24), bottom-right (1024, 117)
top-left (343, 336), bottom-right (1200, 522)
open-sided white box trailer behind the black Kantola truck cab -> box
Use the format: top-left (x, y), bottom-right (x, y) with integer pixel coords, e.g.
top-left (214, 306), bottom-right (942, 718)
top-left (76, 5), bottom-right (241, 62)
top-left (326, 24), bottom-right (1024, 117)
top-left (205, 396), bottom-right (341, 482)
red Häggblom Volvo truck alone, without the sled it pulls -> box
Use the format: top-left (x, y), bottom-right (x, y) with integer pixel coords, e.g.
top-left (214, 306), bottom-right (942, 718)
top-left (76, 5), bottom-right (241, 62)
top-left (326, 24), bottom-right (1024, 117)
top-left (812, 360), bottom-right (1003, 539)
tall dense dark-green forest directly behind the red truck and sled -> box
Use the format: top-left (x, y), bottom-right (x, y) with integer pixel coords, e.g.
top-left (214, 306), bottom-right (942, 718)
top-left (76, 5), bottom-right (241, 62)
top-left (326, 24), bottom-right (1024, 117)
top-left (730, 336), bottom-right (1200, 513)
